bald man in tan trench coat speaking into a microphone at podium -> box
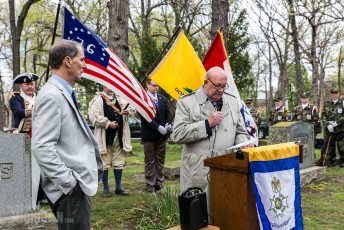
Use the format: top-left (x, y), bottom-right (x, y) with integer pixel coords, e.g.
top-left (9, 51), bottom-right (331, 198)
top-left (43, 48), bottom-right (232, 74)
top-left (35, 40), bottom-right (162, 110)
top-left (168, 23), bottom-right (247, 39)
top-left (172, 67), bottom-right (253, 196)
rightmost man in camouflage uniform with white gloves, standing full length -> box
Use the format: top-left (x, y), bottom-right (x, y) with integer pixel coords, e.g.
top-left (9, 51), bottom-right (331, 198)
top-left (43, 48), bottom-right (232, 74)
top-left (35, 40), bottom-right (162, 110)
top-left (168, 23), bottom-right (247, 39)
top-left (321, 88), bottom-right (344, 168)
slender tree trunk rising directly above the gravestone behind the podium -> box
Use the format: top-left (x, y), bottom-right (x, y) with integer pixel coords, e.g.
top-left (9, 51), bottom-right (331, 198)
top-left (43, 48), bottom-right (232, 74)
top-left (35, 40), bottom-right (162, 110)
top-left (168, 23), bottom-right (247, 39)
top-left (287, 0), bottom-right (303, 98)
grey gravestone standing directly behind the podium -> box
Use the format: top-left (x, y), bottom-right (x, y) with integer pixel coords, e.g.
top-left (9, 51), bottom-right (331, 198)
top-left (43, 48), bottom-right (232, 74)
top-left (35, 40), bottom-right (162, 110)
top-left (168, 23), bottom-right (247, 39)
top-left (269, 122), bottom-right (314, 169)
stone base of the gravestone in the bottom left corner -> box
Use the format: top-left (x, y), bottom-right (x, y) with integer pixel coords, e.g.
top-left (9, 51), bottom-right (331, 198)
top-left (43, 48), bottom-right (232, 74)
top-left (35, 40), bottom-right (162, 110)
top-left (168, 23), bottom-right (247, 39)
top-left (0, 210), bottom-right (57, 230)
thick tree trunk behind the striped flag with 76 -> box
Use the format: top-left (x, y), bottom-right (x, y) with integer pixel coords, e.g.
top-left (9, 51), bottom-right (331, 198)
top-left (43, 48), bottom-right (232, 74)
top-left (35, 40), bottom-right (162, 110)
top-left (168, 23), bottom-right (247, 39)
top-left (108, 0), bottom-right (129, 64)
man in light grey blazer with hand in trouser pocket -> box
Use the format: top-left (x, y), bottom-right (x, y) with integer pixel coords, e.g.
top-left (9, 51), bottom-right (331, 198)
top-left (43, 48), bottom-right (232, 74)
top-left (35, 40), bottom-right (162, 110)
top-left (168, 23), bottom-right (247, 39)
top-left (31, 40), bottom-right (103, 229)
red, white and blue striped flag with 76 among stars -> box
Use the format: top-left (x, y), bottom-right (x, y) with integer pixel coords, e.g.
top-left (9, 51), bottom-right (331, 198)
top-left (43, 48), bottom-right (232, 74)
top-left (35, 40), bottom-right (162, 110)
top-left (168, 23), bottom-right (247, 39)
top-left (62, 7), bottom-right (156, 122)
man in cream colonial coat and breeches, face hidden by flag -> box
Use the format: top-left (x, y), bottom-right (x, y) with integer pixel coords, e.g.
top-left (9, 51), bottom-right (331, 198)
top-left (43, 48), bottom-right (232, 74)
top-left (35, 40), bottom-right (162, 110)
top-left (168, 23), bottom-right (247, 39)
top-left (88, 86), bottom-right (136, 197)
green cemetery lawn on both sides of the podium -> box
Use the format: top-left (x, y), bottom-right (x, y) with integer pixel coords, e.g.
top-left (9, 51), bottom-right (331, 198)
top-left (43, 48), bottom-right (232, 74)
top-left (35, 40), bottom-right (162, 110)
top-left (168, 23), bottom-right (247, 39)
top-left (39, 142), bottom-right (344, 230)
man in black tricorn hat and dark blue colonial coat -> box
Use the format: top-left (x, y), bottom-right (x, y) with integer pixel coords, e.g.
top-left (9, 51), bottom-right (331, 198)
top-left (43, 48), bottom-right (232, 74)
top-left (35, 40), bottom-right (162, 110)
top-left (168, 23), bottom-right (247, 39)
top-left (10, 73), bottom-right (38, 133)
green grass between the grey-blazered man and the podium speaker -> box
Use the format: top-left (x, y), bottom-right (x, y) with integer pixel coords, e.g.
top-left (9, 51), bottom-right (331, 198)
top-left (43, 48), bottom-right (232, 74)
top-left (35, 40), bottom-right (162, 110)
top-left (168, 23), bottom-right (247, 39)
top-left (91, 143), bottom-right (181, 230)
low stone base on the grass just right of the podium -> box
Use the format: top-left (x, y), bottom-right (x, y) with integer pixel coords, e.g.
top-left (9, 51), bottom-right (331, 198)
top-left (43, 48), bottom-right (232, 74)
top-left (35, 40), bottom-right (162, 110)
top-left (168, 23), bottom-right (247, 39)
top-left (300, 166), bottom-right (326, 187)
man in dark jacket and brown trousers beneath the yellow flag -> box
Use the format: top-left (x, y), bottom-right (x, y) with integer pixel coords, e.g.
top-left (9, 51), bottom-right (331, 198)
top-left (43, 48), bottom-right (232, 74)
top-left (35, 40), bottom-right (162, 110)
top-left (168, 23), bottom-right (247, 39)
top-left (141, 79), bottom-right (171, 192)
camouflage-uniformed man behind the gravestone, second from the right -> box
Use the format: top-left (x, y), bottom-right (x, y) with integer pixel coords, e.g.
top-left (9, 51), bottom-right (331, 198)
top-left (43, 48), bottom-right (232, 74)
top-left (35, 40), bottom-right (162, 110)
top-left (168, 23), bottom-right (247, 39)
top-left (293, 93), bottom-right (319, 138)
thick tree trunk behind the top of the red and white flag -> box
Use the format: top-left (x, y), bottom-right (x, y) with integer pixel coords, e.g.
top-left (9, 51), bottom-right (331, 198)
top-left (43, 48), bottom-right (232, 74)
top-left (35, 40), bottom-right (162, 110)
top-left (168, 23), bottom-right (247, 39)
top-left (210, 0), bottom-right (229, 42)
